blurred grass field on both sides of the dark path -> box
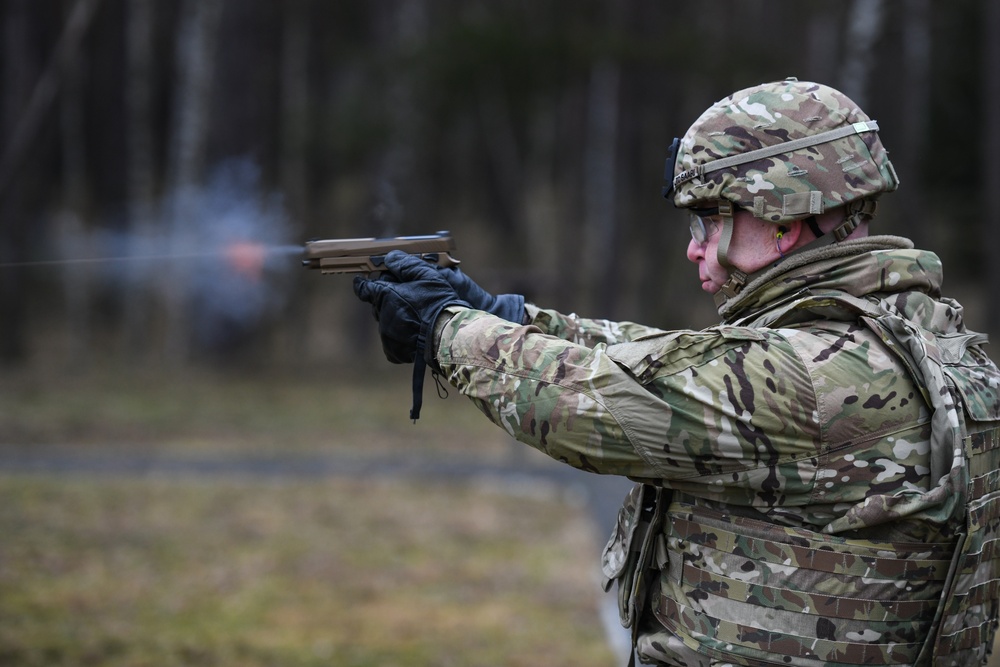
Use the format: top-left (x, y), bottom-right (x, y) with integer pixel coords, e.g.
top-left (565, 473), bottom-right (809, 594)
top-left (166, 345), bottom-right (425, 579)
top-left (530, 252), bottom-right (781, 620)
top-left (0, 373), bottom-right (620, 667)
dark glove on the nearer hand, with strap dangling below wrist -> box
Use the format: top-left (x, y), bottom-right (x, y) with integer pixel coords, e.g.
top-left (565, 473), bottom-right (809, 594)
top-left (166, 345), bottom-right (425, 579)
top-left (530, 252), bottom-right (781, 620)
top-left (354, 250), bottom-right (469, 420)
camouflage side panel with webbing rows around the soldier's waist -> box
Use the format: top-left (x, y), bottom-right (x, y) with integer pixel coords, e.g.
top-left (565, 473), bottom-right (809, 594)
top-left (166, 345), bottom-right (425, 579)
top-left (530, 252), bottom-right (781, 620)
top-left (654, 502), bottom-right (954, 665)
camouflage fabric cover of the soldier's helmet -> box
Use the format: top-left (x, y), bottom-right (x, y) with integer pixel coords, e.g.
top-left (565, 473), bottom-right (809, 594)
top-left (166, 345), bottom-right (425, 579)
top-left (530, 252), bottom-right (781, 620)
top-left (673, 79), bottom-right (898, 222)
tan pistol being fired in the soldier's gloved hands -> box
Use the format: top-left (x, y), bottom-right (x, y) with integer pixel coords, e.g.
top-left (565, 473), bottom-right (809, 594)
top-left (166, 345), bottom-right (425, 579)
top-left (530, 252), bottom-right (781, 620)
top-left (302, 232), bottom-right (459, 273)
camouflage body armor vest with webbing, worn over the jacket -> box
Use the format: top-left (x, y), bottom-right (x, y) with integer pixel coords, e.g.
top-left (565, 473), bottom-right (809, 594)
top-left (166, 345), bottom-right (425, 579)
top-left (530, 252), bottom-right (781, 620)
top-left (602, 292), bottom-right (1000, 667)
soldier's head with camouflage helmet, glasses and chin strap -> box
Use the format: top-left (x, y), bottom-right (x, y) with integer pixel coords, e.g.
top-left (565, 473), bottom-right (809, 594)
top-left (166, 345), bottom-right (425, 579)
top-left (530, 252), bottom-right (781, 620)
top-left (663, 79), bottom-right (898, 305)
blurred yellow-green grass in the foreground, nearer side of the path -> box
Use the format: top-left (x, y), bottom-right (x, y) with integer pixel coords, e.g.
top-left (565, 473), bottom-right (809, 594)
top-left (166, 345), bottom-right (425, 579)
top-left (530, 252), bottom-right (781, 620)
top-left (0, 476), bottom-right (612, 667)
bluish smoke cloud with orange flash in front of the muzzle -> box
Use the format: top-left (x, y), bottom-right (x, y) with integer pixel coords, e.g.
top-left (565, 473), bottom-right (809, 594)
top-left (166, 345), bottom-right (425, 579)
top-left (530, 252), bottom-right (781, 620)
top-left (52, 159), bottom-right (302, 358)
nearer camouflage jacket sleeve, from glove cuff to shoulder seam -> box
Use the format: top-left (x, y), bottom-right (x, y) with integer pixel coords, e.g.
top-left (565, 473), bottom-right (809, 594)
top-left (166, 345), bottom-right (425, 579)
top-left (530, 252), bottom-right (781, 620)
top-left (437, 310), bottom-right (818, 487)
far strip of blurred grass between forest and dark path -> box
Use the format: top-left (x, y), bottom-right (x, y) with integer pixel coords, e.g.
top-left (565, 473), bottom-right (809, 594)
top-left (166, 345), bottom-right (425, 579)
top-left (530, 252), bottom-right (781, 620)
top-left (0, 366), bottom-right (506, 457)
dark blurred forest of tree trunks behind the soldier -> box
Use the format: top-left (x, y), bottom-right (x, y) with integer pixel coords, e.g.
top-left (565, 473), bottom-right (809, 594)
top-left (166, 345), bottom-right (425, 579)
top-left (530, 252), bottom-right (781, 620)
top-left (0, 0), bottom-right (1000, 369)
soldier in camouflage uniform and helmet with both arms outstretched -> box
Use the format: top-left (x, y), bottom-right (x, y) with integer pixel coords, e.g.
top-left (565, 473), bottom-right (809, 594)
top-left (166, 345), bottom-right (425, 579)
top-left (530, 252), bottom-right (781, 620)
top-left (355, 79), bottom-right (1000, 667)
